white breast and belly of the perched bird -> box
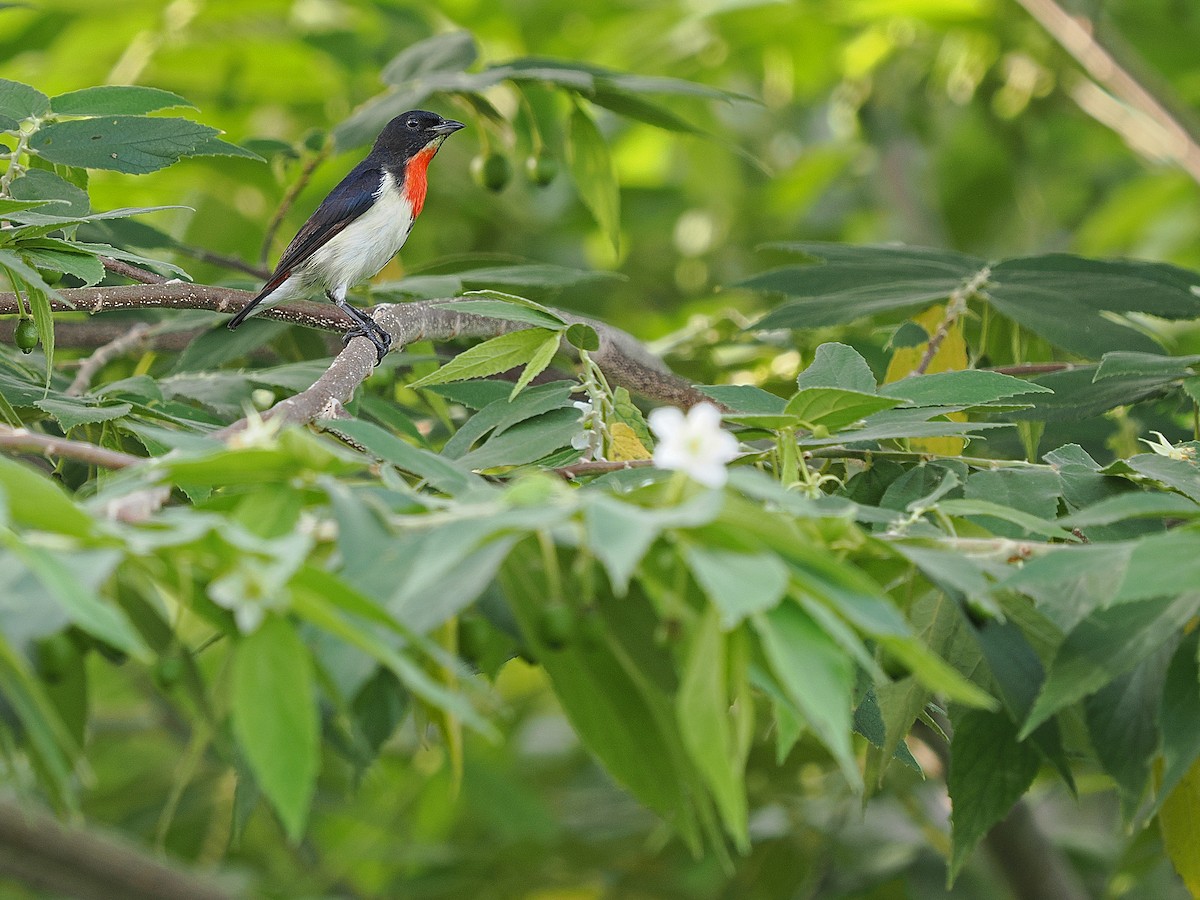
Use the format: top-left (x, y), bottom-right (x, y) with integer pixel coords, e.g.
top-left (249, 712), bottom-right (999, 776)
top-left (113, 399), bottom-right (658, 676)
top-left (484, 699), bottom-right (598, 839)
top-left (304, 172), bottom-right (413, 289)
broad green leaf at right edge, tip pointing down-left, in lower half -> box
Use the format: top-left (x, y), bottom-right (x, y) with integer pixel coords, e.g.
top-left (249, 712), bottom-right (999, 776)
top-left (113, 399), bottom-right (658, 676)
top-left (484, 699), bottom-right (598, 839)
top-left (1021, 593), bottom-right (1200, 738)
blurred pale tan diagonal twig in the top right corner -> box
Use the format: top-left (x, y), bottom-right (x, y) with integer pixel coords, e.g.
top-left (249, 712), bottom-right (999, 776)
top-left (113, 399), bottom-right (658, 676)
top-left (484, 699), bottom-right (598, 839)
top-left (1016, 0), bottom-right (1200, 184)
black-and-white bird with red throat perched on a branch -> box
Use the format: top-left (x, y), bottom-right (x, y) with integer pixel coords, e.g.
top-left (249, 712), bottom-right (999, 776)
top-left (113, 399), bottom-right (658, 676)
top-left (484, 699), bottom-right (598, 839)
top-left (228, 109), bottom-right (466, 365)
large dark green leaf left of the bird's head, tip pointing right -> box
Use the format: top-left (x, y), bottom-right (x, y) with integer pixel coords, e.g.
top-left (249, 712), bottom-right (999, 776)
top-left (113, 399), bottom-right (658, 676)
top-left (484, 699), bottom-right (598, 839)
top-left (30, 115), bottom-right (258, 175)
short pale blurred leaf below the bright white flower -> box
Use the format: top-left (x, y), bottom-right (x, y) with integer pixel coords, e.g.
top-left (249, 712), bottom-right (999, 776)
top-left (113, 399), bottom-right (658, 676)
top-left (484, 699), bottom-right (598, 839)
top-left (684, 545), bottom-right (788, 631)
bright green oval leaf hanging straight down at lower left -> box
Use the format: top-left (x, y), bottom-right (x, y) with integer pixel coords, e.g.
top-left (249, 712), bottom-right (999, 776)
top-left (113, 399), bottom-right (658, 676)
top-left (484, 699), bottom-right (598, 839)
top-left (232, 616), bottom-right (320, 842)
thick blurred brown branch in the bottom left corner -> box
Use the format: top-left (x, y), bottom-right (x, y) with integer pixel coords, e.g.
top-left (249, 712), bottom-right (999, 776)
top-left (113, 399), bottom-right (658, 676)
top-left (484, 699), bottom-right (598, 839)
top-left (0, 800), bottom-right (233, 900)
